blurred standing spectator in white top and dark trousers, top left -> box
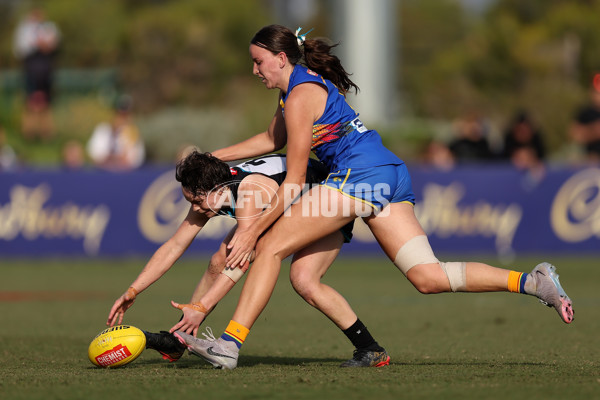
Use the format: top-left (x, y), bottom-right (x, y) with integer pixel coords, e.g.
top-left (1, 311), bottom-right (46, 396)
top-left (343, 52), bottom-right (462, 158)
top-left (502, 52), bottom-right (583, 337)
top-left (14, 8), bottom-right (60, 139)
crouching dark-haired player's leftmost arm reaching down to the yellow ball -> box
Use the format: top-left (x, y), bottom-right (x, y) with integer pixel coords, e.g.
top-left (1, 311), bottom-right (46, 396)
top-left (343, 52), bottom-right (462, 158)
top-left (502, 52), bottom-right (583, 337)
top-left (106, 207), bottom-right (209, 326)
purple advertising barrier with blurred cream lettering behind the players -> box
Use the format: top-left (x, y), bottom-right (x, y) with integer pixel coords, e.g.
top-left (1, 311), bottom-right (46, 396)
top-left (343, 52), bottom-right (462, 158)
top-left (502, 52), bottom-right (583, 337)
top-left (0, 166), bottom-right (600, 257)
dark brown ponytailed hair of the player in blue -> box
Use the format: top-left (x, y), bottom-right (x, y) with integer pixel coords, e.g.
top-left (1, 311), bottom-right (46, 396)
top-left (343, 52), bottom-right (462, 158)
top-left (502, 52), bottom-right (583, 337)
top-left (250, 25), bottom-right (359, 95)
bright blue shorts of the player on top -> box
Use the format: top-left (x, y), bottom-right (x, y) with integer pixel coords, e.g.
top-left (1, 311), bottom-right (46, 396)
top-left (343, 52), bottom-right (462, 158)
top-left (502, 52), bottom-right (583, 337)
top-left (321, 164), bottom-right (415, 211)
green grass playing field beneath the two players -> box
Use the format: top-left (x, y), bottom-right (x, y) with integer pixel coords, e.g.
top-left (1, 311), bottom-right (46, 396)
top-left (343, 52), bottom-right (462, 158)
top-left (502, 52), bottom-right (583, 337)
top-left (0, 258), bottom-right (600, 400)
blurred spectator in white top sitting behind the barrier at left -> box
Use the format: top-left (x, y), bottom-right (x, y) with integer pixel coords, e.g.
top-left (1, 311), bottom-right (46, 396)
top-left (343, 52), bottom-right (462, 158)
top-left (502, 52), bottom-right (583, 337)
top-left (87, 96), bottom-right (146, 171)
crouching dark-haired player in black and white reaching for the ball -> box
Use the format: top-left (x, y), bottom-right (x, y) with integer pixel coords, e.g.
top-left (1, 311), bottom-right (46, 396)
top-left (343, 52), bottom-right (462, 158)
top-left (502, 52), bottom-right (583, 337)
top-left (107, 151), bottom-right (389, 367)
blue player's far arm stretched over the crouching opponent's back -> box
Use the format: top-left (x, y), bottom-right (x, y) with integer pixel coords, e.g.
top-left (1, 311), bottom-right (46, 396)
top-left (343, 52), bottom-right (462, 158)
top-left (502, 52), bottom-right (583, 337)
top-left (211, 106), bottom-right (286, 161)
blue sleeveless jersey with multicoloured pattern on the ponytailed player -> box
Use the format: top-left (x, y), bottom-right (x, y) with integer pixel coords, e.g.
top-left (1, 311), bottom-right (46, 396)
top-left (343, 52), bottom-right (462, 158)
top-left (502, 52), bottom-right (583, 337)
top-left (280, 65), bottom-right (403, 171)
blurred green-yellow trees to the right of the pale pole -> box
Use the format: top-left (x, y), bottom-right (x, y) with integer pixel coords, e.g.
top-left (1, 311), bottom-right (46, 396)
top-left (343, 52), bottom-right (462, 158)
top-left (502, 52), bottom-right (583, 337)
top-left (400, 0), bottom-right (600, 156)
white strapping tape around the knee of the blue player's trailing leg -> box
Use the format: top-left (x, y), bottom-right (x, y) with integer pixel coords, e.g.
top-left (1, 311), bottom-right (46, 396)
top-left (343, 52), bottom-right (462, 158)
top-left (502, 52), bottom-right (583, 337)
top-left (394, 235), bottom-right (467, 292)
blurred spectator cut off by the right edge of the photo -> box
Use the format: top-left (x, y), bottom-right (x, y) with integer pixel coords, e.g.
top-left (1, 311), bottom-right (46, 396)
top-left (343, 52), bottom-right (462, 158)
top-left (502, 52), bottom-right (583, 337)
top-left (569, 82), bottom-right (600, 163)
